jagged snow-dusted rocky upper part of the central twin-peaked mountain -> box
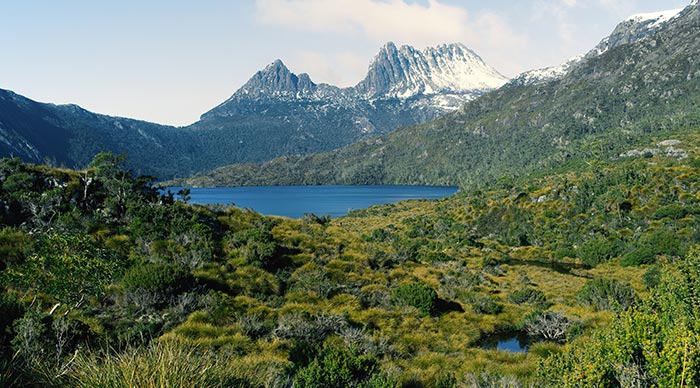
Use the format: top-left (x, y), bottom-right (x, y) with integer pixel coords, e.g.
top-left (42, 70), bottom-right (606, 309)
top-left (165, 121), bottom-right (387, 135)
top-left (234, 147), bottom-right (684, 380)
top-left (202, 42), bottom-right (508, 119)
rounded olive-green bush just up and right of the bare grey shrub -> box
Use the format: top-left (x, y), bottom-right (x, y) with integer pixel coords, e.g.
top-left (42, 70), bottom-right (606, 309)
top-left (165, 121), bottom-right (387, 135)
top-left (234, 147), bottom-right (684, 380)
top-left (576, 279), bottom-right (637, 311)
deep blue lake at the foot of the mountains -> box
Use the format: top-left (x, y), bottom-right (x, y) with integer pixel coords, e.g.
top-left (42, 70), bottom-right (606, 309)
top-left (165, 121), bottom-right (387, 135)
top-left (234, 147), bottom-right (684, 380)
top-left (170, 186), bottom-right (457, 218)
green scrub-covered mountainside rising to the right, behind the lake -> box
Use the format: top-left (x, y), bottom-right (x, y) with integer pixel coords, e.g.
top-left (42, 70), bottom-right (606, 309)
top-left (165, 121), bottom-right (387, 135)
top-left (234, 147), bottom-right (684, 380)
top-left (176, 2), bottom-right (700, 187)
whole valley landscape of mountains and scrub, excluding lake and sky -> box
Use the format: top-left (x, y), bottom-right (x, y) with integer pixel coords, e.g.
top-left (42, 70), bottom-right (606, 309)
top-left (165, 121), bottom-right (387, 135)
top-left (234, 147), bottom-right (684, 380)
top-left (0, 0), bottom-right (700, 388)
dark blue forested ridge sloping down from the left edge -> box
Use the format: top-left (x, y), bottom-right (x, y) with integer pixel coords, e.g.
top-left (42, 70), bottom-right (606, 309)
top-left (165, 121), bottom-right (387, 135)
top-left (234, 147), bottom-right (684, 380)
top-left (0, 89), bottom-right (202, 176)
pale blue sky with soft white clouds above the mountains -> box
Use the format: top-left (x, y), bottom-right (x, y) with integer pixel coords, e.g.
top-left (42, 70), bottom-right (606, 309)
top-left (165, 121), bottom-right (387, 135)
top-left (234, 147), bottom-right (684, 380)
top-left (0, 0), bottom-right (690, 126)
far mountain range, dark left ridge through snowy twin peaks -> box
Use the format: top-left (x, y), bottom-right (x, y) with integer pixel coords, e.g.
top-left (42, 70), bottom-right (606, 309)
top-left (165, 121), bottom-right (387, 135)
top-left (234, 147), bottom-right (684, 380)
top-left (0, 43), bottom-right (507, 178)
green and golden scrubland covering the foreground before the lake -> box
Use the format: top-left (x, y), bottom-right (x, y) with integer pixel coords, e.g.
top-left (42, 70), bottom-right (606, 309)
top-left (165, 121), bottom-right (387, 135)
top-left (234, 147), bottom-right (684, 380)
top-left (0, 131), bottom-right (700, 388)
